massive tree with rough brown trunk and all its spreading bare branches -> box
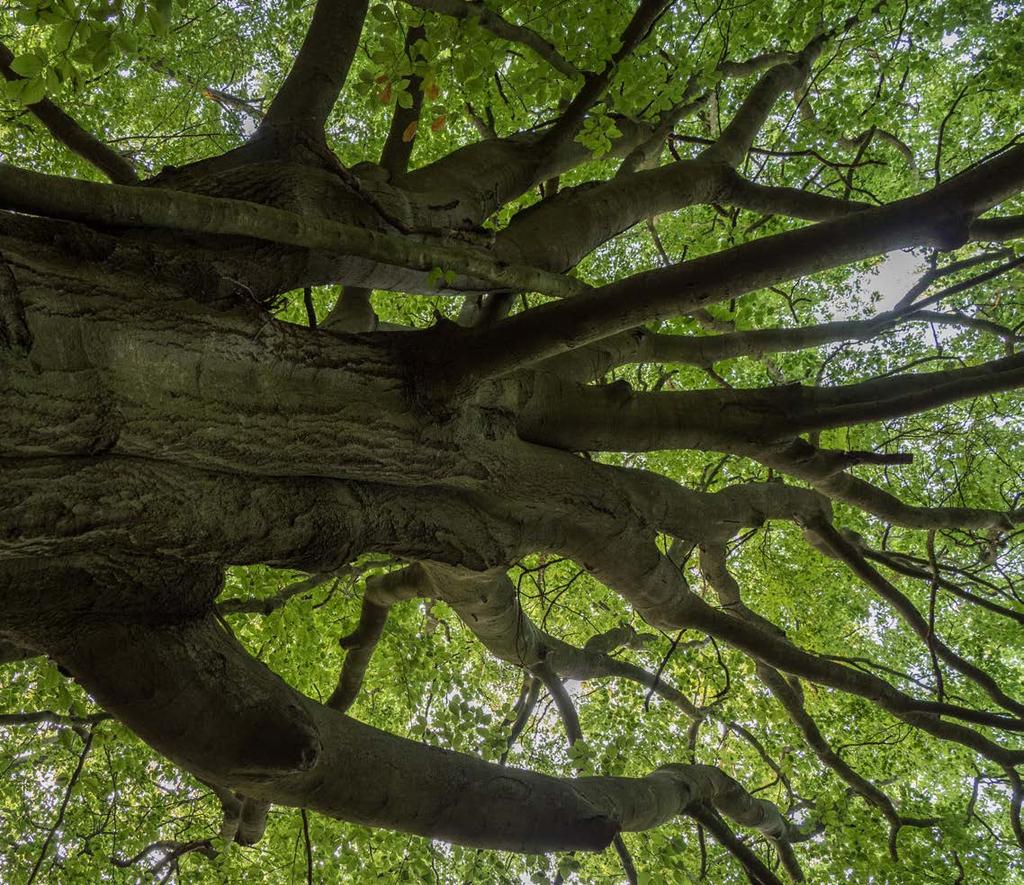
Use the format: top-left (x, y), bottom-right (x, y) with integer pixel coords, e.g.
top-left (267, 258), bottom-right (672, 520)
top-left (6, 0), bottom-right (1024, 882)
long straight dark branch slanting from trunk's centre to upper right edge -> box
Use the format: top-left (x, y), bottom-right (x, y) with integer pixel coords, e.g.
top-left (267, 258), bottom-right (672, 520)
top-left (447, 141), bottom-right (1024, 379)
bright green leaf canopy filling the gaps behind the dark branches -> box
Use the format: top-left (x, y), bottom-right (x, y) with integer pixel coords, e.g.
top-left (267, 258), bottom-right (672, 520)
top-left (0, 0), bottom-right (1024, 885)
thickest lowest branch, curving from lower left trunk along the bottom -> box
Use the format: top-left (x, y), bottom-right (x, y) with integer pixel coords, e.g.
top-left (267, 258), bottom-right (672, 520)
top-left (24, 563), bottom-right (815, 852)
